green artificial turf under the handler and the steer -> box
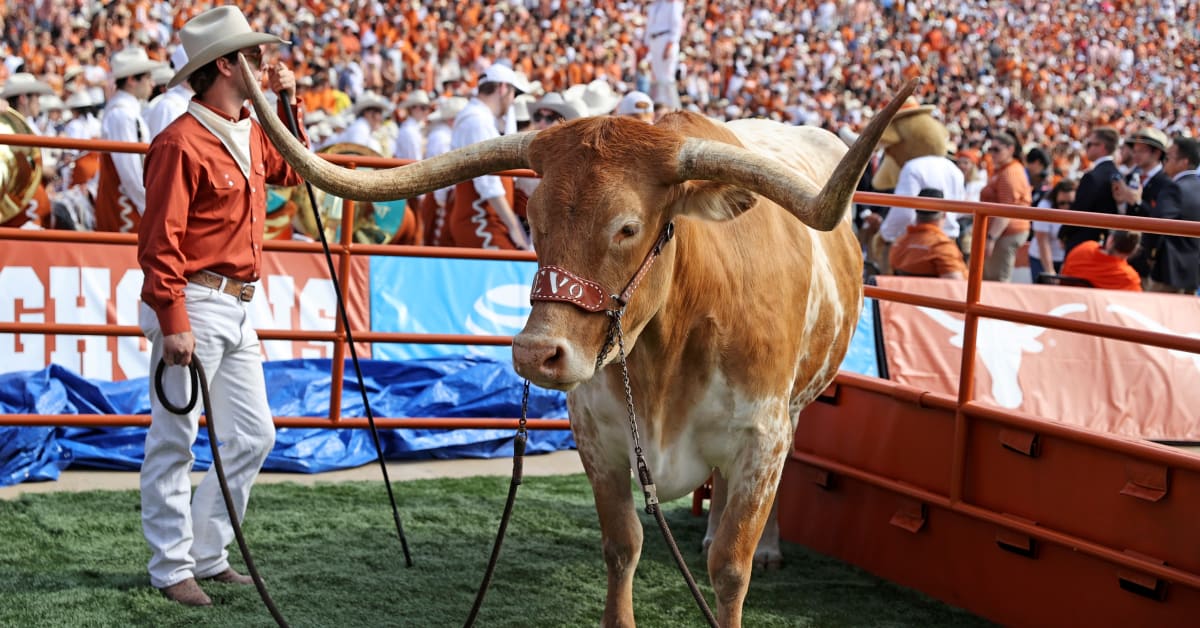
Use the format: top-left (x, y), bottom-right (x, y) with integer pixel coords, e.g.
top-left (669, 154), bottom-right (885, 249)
top-left (0, 476), bottom-right (986, 628)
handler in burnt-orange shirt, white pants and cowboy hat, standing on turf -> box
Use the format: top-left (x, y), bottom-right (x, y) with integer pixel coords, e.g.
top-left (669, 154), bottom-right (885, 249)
top-left (138, 6), bottom-right (307, 606)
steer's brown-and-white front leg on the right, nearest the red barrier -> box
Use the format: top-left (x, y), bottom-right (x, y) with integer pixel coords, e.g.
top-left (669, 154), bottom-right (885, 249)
top-left (708, 419), bottom-right (790, 628)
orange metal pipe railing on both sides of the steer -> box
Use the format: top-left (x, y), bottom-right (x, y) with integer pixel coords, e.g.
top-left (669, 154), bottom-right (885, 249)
top-left (0, 134), bottom-right (1200, 446)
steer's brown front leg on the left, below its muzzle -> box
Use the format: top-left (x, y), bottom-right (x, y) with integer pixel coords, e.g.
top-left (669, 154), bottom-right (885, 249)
top-left (572, 437), bottom-right (642, 627)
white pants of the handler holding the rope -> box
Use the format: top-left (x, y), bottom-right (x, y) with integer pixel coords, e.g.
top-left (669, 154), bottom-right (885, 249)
top-left (139, 283), bottom-right (275, 588)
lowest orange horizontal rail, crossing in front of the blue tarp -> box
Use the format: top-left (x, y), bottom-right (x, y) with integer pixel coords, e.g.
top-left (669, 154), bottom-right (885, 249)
top-left (0, 414), bottom-right (571, 430)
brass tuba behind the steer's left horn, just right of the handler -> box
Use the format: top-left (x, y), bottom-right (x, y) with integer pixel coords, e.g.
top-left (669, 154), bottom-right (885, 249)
top-left (266, 143), bottom-right (414, 244)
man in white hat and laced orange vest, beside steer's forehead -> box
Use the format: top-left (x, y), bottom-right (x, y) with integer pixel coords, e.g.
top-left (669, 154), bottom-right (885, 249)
top-left (446, 64), bottom-right (533, 250)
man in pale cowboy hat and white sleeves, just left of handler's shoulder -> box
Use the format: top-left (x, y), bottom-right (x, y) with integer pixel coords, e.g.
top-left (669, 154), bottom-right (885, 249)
top-left (96, 47), bottom-right (164, 233)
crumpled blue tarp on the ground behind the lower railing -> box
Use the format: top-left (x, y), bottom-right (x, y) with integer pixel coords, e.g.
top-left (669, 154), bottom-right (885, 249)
top-left (0, 357), bottom-right (575, 485)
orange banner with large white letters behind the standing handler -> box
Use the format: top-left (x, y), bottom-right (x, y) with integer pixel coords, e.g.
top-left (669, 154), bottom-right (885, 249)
top-left (0, 241), bottom-right (370, 381)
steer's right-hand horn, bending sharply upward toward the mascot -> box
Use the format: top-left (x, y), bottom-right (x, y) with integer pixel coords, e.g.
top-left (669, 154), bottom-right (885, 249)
top-left (677, 79), bottom-right (917, 231)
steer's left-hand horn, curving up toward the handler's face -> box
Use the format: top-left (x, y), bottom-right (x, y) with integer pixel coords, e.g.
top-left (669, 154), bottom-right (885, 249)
top-left (239, 55), bottom-right (534, 201)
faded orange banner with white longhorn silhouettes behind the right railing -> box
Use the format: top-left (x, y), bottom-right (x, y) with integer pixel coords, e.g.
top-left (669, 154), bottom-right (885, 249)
top-left (876, 276), bottom-right (1200, 441)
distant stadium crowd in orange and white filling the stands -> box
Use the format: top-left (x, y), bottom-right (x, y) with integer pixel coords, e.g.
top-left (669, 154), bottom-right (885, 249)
top-left (0, 0), bottom-right (1200, 292)
